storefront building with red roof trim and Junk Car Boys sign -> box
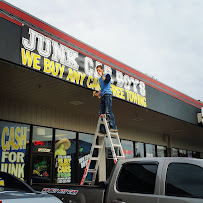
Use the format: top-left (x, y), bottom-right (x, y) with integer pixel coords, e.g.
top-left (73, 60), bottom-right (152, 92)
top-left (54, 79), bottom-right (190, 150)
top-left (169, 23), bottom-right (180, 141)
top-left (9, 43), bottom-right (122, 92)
top-left (0, 1), bottom-right (203, 184)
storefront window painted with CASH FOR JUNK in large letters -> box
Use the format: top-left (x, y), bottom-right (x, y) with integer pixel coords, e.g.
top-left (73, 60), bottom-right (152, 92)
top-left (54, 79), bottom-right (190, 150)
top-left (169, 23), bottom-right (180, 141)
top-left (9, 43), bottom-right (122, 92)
top-left (0, 122), bottom-right (30, 181)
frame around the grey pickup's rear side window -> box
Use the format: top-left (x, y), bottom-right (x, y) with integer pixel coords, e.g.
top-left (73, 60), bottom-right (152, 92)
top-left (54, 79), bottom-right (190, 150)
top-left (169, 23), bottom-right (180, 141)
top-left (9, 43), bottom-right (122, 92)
top-left (115, 161), bottom-right (159, 195)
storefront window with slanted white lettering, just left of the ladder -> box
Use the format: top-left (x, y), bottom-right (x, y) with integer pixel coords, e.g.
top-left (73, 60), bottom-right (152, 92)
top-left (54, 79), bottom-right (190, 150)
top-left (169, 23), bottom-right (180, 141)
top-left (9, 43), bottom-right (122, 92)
top-left (78, 133), bottom-right (94, 181)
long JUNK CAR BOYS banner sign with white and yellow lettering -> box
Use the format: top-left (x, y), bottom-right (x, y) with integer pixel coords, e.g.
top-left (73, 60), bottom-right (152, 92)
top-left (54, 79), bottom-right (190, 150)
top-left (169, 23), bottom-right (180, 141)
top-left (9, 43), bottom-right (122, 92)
top-left (21, 26), bottom-right (147, 107)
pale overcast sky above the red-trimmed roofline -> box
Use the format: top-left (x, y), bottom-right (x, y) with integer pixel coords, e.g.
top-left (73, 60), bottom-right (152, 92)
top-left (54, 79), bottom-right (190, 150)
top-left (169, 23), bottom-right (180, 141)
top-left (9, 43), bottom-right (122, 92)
top-left (4, 0), bottom-right (203, 101)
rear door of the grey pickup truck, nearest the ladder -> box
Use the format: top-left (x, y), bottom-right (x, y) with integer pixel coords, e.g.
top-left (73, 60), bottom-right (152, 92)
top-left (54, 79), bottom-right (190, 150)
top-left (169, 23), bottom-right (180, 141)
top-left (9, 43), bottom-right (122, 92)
top-left (107, 160), bottom-right (160, 203)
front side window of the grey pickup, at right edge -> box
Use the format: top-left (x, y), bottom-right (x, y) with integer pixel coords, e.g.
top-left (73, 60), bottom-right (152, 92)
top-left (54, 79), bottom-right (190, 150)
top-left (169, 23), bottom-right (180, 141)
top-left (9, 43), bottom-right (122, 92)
top-left (165, 163), bottom-right (203, 198)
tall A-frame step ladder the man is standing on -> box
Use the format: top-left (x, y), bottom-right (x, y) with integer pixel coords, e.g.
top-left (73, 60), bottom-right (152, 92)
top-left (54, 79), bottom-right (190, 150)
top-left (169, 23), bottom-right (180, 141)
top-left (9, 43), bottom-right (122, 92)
top-left (80, 114), bottom-right (125, 185)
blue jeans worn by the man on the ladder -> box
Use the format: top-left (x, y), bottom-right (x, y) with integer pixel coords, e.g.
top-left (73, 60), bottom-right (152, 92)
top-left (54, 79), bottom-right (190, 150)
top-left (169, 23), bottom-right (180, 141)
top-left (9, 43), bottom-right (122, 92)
top-left (99, 94), bottom-right (117, 133)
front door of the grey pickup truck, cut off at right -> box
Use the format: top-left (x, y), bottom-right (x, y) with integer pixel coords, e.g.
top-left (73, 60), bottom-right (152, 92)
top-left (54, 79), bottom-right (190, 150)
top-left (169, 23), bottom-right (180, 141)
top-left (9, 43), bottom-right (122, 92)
top-left (159, 158), bottom-right (203, 203)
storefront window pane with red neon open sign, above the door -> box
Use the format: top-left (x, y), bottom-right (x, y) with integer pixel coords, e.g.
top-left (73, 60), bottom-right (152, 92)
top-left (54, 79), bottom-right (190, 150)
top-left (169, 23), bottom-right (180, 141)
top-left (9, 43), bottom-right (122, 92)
top-left (32, 126), bottom-right (53, 152)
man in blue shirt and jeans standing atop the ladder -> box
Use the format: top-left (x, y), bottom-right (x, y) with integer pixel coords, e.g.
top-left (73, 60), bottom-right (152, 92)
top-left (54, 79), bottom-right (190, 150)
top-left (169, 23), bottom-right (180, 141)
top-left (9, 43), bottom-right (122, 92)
top-left (95, 65), bottom-right (118, 133)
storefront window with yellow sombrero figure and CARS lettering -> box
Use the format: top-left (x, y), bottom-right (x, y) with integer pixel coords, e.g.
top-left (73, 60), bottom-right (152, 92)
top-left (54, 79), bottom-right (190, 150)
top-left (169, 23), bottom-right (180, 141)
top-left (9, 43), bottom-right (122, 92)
top-left (54, 130), bottom-right (78, 183)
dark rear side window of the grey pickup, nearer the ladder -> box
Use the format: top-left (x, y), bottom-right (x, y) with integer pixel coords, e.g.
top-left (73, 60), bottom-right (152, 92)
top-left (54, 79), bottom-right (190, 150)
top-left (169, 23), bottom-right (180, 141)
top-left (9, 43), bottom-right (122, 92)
top-left (117, 163), bottom-right (158, 194)
